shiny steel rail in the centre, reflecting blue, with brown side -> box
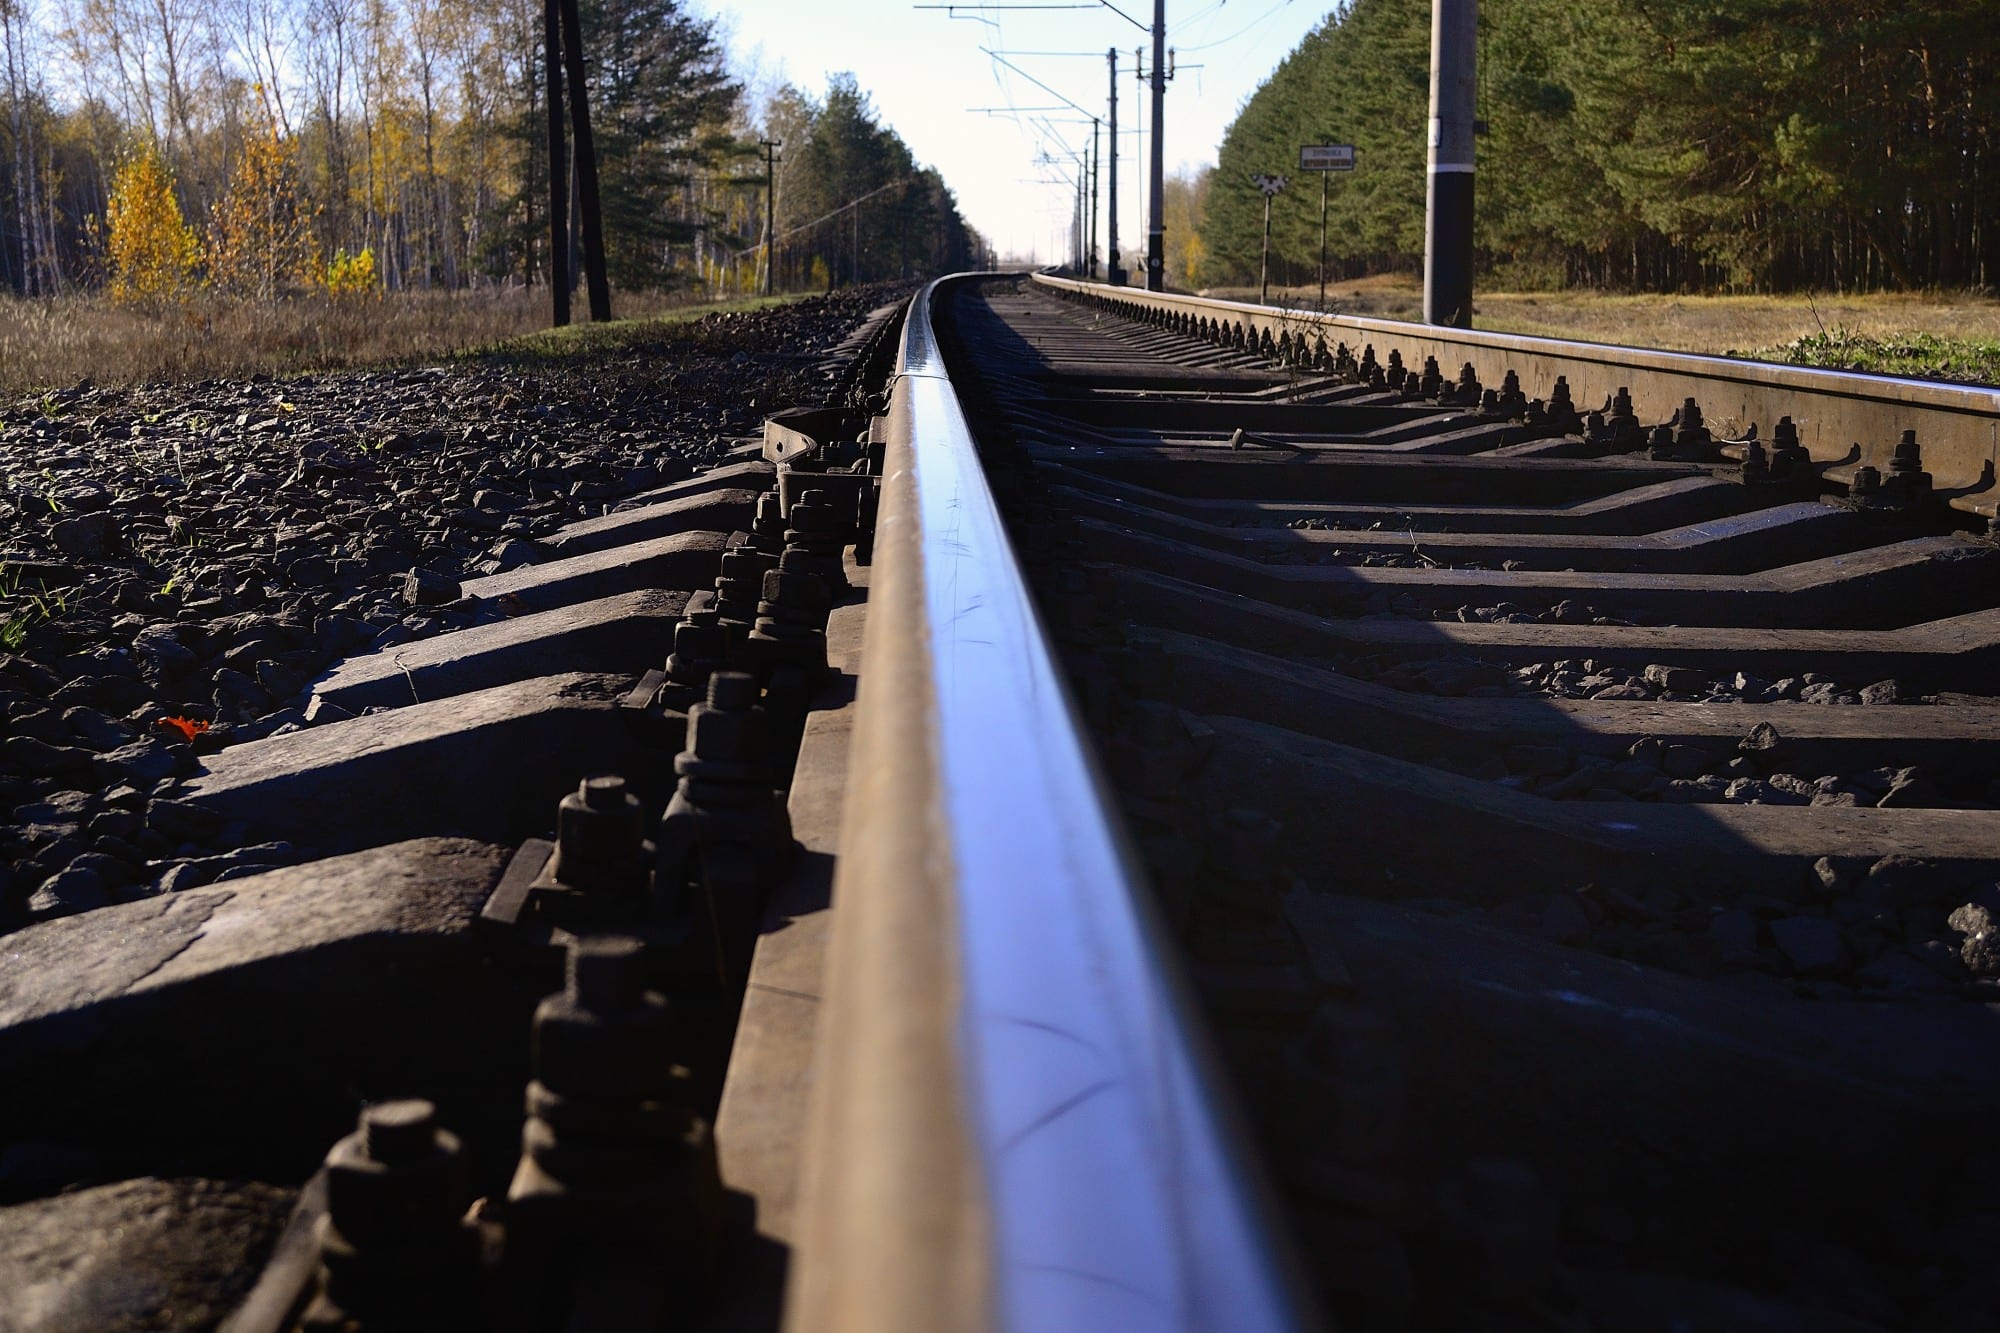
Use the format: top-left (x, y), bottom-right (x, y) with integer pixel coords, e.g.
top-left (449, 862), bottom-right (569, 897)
top-left (786, 276), bottom-right (1304, 1333)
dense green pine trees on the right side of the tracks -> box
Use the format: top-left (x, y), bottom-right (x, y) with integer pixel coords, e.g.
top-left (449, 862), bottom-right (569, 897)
top-left (1196, 0), bottom-right (2000, 290)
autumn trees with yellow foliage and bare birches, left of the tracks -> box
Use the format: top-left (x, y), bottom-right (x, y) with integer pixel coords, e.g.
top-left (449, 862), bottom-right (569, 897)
top-left (0, 0), bottom-right (978, 296)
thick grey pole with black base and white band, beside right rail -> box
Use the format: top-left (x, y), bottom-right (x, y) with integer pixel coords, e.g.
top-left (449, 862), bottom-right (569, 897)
top-left (1424, 0), bottom-right (1480, 328)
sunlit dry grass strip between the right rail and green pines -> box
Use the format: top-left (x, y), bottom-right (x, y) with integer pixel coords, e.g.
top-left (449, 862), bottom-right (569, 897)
top-left (1206, 274), bottom-right (2000, 380)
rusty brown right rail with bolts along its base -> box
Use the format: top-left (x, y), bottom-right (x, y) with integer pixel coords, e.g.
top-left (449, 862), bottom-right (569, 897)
top-left (1034, 274), bottom-right (2000, 518)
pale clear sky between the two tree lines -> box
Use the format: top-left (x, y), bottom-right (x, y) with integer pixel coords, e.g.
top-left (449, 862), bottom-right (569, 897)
top-left (694, 0), bottom-right (1330, 270)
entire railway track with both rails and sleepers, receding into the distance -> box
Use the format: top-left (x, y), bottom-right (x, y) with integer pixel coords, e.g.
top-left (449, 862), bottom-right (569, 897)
top-left (0, 276), bottom-right (2000, 1333)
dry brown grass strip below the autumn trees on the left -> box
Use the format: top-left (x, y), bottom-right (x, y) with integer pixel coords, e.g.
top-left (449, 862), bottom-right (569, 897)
top-left (0, 288), bottom-right (784, 394)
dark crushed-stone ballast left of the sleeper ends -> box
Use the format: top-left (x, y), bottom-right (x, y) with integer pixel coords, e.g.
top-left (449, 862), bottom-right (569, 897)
top-left (0, 284), bottom-right (912, 931)
